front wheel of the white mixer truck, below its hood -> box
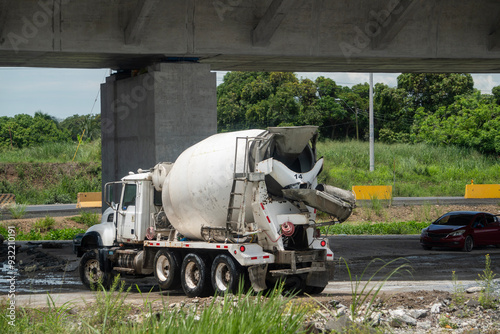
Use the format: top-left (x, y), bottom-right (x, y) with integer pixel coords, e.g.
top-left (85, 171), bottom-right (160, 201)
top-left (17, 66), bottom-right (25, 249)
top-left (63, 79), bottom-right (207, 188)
top-left (78, 250), bottom-right (113, 290)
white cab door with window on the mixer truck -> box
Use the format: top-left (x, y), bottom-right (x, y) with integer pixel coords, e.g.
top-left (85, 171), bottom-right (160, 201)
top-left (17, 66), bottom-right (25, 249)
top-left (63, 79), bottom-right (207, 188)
top-left (117, 183), bottom-right (137, 242)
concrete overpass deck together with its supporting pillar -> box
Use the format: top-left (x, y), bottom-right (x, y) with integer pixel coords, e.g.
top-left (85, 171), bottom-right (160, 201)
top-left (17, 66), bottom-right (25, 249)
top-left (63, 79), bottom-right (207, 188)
top-left (0, 0), bottom-right (500, 180)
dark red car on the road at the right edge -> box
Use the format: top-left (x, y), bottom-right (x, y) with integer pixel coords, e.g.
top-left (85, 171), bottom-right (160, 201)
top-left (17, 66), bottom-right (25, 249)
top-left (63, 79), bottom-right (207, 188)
top-left (420, 211), bottom-right (500, 252)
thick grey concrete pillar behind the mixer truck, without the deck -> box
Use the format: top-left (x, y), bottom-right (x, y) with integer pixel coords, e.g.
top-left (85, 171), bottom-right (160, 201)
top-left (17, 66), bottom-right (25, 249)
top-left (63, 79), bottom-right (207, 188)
top-left (101, 63), bottom-right (217, 185)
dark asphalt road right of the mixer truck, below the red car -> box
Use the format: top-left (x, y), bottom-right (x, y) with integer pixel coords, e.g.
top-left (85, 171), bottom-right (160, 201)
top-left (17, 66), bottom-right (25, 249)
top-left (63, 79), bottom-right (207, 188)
top-left (329, 235), bottom-right (500, 281)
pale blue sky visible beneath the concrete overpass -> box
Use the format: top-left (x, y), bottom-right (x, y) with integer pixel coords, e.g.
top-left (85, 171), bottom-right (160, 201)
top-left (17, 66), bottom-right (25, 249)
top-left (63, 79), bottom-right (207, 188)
top-left (0, 67), bottom-right (500, 120)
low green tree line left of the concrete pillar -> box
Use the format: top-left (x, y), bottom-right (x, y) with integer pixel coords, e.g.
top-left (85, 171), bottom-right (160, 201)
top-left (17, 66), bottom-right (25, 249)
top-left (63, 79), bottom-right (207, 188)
top-left (0, 111), bottom-right (101, 148)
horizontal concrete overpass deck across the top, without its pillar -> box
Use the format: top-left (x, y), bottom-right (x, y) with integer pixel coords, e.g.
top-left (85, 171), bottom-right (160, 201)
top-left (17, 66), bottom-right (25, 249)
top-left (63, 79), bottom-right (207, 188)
top-left (0, 0), bottom-right (500, 73)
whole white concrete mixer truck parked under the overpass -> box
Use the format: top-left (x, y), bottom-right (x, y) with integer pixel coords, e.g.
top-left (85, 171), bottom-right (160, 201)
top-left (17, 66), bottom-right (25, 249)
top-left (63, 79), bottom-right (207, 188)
top-left (74, 126), bottom-right (355, 297)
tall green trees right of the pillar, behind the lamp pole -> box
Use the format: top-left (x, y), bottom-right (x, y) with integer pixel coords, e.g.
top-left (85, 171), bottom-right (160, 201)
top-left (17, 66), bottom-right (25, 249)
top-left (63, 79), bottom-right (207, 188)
top-left (217, 72), bottom-right (500, 153)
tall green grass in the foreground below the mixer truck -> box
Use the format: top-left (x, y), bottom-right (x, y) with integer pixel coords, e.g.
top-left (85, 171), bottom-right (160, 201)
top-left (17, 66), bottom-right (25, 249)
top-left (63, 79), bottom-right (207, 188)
top-left (0, 280), bottom-right (309, 334)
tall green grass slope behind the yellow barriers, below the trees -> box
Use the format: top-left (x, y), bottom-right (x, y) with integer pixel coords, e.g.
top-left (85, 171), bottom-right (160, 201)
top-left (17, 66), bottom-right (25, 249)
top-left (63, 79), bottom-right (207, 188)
top-left (318, 141), bottom-right (500, 197)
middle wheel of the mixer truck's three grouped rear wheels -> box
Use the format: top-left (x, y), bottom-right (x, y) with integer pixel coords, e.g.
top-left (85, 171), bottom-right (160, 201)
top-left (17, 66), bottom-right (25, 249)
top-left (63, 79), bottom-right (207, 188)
top-left (181, 253), bottom-right (213, 298)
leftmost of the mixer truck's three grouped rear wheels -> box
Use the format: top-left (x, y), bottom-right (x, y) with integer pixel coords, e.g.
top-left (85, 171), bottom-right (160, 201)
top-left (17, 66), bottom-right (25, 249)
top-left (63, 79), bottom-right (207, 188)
top-left (154, 249), bottom-right (181, 290)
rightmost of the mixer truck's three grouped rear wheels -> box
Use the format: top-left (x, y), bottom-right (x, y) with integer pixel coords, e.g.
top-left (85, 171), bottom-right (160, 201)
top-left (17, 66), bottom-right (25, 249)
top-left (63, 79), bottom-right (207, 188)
top-left (210, 254), bottom-right (243, 295)
